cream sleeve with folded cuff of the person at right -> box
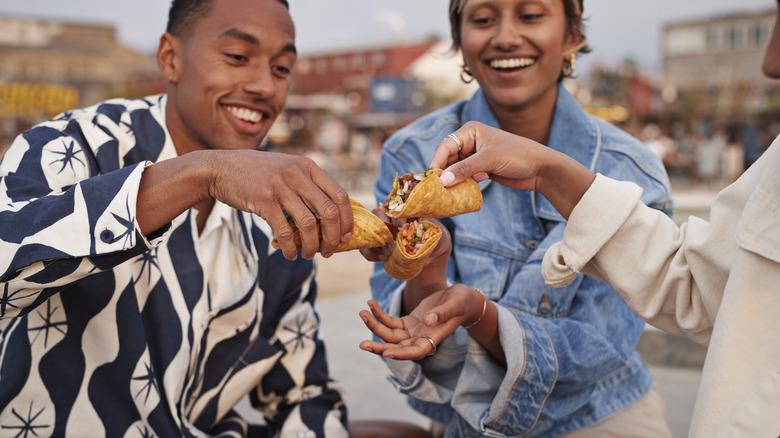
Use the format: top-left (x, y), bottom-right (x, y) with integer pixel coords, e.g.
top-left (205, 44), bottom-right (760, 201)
top-left (543, 175), bottom-right (728, 345)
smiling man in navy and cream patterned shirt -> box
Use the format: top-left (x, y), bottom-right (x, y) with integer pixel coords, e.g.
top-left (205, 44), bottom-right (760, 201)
top-left (0, 0), bottom-right (352, 437)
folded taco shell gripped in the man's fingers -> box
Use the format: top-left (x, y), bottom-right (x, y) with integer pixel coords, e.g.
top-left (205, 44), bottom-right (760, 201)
top-left (271, 199), bottom-right (393, 252)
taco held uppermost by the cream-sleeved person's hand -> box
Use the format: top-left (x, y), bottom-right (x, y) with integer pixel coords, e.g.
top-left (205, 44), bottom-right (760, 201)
top-left (380, 169), bottom-right (482, 218)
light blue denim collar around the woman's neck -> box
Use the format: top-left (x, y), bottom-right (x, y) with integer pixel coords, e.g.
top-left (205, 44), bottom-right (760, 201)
top-left (461, 84), bottom-right (601, 221)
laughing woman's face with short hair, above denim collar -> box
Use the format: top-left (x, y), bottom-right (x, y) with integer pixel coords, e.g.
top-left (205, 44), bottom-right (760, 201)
top-left (460, 0), bottom-right (579, 113)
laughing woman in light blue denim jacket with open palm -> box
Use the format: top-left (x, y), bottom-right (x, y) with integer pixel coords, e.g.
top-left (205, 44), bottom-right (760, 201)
top-left (361, 0), bottom-right (672, 437)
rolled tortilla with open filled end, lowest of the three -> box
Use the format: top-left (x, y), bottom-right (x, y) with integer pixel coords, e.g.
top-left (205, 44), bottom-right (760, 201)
top-left (384, 220), bottom-right (441, 280)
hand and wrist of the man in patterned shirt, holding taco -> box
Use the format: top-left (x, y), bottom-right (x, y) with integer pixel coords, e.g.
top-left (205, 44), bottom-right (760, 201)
top-left (136, 150), bottom-right (353, 260)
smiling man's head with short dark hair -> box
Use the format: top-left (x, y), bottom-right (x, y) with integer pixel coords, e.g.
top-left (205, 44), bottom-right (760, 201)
top-left (166, 0), bottom-right (296, 154)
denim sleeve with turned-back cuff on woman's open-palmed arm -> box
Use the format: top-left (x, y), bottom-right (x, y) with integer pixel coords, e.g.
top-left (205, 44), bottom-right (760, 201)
top-left (444, 224), bottom-right (647, 436)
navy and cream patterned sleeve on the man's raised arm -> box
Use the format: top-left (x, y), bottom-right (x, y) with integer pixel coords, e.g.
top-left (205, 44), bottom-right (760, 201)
top-left (0, 120), bottom-right (167, 318)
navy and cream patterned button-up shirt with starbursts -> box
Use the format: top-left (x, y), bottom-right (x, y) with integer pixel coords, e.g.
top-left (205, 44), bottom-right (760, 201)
top-left (0, 95), bottom-right (347, 437)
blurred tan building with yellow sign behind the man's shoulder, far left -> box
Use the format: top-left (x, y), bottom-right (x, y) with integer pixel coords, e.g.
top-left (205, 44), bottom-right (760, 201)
top-left (0, 16), bottom-right (165, 149)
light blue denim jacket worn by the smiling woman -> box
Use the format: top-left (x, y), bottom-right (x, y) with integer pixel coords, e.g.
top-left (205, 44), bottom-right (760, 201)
top-left (371, 86), bottom-right (673, 437)
